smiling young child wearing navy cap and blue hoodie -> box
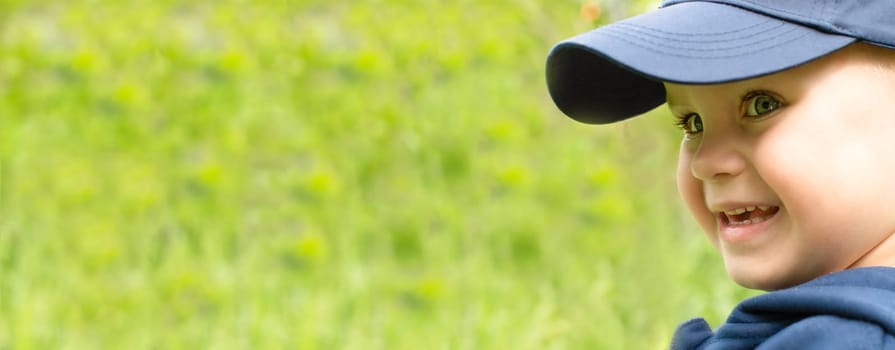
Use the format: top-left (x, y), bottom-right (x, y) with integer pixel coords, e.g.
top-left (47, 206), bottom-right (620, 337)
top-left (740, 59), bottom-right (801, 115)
top-left (547, 0), bottom-right (895, 349)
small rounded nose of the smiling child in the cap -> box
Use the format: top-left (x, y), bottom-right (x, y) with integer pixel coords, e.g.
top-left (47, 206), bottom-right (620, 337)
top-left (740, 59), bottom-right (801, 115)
top-left (690, 133), bottom-right (746, 181)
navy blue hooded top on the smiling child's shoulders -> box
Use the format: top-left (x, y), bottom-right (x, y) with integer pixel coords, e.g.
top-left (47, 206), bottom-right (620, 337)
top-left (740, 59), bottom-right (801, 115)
top-left (671, 267), bottom-right (895, 350)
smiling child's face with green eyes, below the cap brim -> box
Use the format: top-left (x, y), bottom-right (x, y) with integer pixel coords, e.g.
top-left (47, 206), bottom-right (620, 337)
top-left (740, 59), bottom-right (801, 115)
top-left (666, 44), bottom-right (895, 290)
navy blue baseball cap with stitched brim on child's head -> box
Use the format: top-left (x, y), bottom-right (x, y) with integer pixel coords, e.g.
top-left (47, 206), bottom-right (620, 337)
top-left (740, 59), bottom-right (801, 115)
top-left (546, 0), bottom-right (895, 124)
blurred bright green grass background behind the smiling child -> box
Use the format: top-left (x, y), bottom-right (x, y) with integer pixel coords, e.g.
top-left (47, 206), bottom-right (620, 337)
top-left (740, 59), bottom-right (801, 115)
top-left (0, 0), bottom-right (750, 349)
